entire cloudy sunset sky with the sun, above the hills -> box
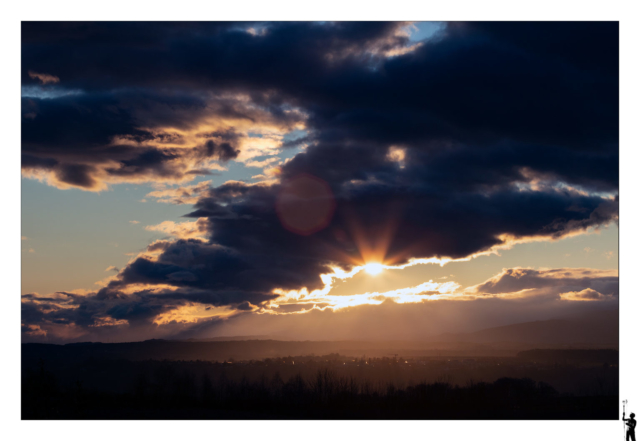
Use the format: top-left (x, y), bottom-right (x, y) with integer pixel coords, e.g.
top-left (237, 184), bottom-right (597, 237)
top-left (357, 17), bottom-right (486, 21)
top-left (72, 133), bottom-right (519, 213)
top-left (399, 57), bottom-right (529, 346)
top-left (21, 22), bottom-right (619, 342)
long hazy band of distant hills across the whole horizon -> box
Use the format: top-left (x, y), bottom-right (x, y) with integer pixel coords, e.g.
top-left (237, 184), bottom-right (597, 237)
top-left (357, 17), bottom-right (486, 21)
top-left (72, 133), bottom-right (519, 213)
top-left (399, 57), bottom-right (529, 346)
top-left (22, 310), bottom-right (618, 363)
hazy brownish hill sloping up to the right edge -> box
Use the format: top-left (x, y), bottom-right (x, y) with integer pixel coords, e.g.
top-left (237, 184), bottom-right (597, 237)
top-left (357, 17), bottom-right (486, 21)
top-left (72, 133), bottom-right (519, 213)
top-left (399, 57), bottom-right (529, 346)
top-left (439, 310), bottom-right (619, 348)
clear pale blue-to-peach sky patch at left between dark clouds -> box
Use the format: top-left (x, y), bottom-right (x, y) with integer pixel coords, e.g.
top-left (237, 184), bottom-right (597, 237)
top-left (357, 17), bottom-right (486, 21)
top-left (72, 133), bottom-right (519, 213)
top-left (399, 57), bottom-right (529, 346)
top-left (21, 130), bottom-right (307, 294)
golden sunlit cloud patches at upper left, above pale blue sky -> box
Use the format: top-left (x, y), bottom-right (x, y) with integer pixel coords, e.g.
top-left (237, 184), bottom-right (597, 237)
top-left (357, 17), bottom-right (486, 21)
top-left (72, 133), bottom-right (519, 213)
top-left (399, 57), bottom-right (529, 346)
top-left (22, 90), bottom-right (308, 192)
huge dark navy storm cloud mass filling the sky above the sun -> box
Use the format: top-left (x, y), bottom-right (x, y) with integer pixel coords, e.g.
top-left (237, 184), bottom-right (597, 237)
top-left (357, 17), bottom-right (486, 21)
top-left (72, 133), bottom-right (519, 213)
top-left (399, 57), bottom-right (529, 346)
top-left (22, 22), bottom-right (618, 336)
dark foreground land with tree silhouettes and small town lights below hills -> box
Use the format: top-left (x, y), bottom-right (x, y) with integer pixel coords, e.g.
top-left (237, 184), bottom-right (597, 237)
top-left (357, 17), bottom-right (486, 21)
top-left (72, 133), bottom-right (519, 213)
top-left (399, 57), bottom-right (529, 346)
top-left (22, 345), bottom-right (618, 419)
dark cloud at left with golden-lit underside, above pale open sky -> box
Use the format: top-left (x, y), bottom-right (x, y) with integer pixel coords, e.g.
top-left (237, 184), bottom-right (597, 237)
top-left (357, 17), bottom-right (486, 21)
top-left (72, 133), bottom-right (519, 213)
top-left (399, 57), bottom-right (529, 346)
top-left (22, 86), bottom-right (300, 189)
